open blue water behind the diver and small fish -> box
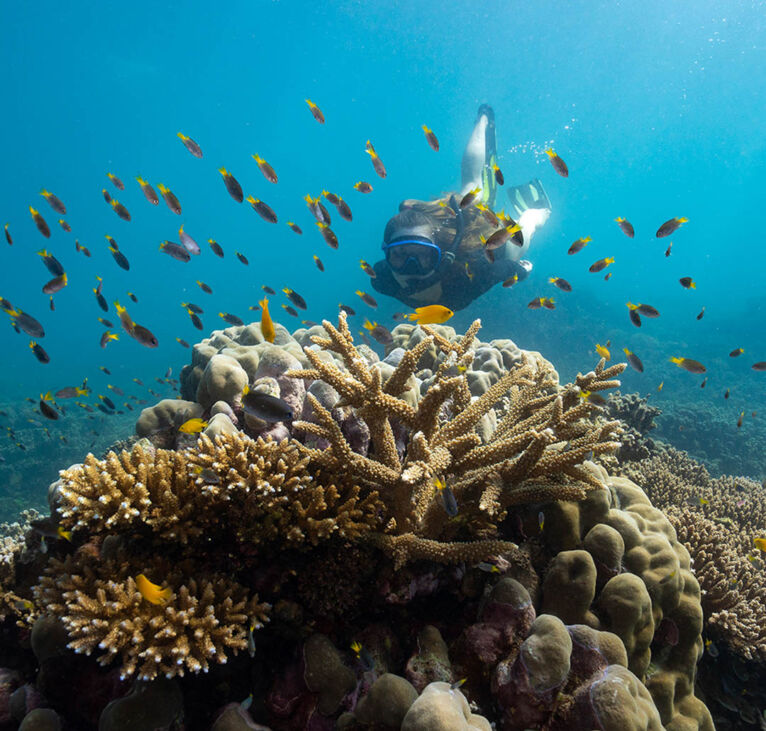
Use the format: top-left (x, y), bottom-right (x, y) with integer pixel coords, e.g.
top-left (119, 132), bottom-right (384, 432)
top-left (0, 0), bottom-right (766, 516)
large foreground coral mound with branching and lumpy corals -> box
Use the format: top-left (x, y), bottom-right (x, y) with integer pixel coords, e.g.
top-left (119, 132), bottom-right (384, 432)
top-left (3, 315), bottom-right (720, 731)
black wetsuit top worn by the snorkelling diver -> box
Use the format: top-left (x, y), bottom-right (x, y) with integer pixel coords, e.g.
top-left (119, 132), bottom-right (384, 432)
top-left (372, 250), bottom-right (528, 312)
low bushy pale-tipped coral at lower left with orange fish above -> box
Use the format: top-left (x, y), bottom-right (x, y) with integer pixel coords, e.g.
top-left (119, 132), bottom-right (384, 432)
top-left (35, 555), bottom-right (269, 680)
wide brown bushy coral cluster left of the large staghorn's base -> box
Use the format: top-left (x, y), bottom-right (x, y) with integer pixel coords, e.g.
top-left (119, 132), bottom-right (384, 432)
top-left (55, 433), bottom-right (380, 545)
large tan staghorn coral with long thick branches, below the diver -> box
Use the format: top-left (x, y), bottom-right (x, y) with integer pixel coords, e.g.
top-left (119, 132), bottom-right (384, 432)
top-left (287, 313), bottom-right (625, 563)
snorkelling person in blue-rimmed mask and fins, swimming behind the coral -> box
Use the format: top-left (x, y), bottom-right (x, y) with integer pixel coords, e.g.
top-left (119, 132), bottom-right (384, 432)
top-left (372, 104), bottom-right (551, 311)
